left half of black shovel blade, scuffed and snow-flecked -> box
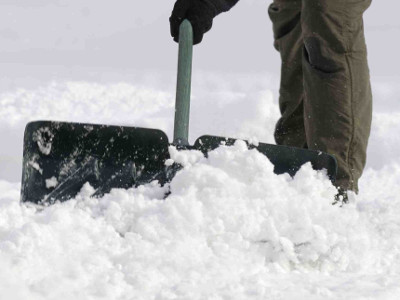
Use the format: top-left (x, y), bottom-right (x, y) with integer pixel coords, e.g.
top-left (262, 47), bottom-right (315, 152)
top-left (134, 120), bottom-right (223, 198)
top-left (21, 121), bottom-right (169, 204)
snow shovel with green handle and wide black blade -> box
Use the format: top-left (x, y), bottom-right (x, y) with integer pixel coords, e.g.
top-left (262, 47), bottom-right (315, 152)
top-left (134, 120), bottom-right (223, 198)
top-left (21, 20), bottom-right (337, 205)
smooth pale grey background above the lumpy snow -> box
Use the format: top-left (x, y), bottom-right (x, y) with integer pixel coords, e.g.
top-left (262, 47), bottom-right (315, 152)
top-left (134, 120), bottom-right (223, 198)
top-left (0, 0), bottom-right (400, 87)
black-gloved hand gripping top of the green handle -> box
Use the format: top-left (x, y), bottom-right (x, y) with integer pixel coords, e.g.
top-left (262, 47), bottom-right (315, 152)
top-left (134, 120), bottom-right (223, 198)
top-left (169, 0), bottom-right (218, 45)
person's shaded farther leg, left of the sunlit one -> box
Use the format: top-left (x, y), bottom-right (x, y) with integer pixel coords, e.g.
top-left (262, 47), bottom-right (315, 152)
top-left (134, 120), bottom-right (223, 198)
top-left (268, 0), bottom-right (307, 148)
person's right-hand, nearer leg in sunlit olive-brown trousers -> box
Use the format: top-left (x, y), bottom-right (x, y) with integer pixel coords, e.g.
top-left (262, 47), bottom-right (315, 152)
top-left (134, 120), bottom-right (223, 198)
top-left (301, 0), bottom-right (372, 192)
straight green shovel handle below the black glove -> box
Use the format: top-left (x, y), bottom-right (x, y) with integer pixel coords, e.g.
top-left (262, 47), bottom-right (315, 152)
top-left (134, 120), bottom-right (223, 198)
top-left (173, 20), bottom-right (193, 146)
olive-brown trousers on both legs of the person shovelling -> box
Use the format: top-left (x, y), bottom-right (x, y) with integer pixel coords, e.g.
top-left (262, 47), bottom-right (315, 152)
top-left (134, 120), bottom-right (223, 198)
top-left (269, 0), bottom-right (372, 192)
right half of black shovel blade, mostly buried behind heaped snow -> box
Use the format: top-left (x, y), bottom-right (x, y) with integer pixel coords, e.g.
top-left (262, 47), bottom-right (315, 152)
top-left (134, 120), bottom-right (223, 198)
top-left (193, 135), bottom-right (337, 182)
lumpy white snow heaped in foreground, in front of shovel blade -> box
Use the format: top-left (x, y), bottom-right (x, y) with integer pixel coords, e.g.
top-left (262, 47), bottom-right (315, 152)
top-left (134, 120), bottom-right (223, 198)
top-left (0, 142), bottom-right (400, 299)
